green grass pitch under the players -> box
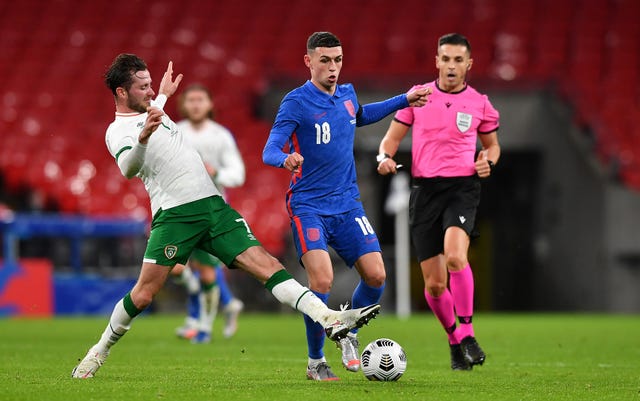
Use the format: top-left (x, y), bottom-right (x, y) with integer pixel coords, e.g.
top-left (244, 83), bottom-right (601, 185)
top-left (0, 313), bottom-right (640, 401)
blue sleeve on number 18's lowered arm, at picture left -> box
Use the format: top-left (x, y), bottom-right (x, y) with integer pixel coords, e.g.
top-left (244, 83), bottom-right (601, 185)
top-left (262, 98), bottom-right (301, 167)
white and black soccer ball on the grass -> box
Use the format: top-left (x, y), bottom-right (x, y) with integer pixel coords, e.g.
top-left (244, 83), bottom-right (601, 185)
top-left (360, 338), bottom-right (407, 381)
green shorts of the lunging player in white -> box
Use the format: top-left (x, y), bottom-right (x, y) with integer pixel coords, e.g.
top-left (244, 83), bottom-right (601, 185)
top-left (144, 196), bottom-right (260, 268)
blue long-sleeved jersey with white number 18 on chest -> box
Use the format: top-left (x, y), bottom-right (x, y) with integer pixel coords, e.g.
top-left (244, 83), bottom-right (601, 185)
top-left (263, 81), bottom-right (408, 216)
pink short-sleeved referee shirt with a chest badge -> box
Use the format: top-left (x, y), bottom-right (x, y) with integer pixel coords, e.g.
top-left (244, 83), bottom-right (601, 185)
top-left (395, 81), bottom-right (500, 178)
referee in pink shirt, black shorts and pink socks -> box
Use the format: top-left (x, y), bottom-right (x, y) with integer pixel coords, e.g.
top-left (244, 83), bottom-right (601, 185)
top-left (378, 34), bottom-right (500, 370)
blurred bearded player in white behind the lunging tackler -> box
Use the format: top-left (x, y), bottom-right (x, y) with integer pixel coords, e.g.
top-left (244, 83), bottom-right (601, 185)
top-left (174, 84), bottom-right (245, 343)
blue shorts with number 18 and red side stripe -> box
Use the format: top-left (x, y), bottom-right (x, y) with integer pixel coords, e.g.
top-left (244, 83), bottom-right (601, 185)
top-left (291, 207), bottom-right (381, 267)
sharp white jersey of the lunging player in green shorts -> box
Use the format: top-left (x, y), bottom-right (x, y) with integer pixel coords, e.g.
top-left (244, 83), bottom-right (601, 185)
top-left (105, 95), bottom-right (221, 215)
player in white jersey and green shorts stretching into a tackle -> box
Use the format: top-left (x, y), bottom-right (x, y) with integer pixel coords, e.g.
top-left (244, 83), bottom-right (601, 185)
top-left (71, 54), bottom-right (380, 379)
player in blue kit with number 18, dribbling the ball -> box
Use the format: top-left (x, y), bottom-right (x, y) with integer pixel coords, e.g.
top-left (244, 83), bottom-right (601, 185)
top-left (262, 32), bottom-right (430, 380)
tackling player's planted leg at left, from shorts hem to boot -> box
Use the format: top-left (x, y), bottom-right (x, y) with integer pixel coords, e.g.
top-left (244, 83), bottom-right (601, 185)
top-left (71, 262), bottom-right (170, 379)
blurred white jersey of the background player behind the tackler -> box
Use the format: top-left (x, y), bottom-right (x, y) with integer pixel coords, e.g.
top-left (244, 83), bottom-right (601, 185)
top-left (178, 120), bottom-right (245, 192)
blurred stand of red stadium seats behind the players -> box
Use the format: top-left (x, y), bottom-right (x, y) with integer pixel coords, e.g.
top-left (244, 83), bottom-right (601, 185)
top-left (0, 0), bottom-right (640, 254)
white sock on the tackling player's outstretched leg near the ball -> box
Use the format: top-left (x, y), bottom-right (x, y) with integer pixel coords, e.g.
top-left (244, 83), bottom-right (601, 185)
top-left (271, 278), bottom-right (338, 326)
